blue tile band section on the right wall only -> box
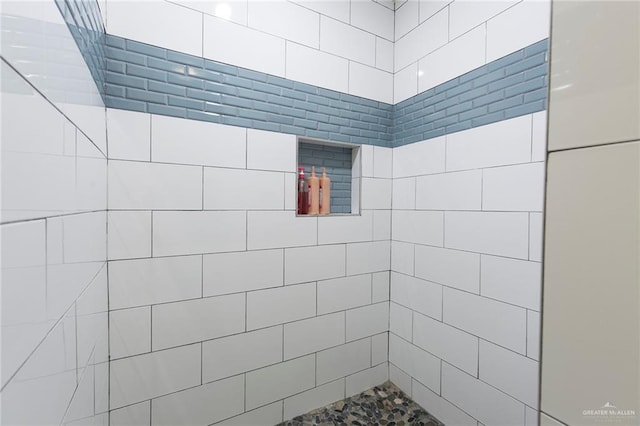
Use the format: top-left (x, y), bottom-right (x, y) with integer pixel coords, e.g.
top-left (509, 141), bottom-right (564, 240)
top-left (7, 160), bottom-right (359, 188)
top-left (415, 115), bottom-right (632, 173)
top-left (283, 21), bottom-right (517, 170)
top-left (392, 39), bottom-right (548, 146)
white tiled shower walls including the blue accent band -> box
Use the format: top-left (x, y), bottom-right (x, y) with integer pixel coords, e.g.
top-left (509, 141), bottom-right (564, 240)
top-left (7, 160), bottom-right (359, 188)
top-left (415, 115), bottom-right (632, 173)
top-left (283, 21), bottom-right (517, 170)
top-left (0, 0), bottom-right (549, 425)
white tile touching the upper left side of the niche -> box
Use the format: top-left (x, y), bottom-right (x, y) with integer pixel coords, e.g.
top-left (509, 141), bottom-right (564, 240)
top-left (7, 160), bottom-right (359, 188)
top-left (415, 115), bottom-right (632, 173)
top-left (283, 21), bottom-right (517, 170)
top-left (247, 129), bottom-right (296, 172)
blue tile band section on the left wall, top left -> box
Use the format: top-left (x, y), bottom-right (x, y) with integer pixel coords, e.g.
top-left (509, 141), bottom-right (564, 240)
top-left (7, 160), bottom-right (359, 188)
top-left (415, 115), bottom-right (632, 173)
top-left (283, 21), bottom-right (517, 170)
top-left (55, 0), bottom-right (106, 100)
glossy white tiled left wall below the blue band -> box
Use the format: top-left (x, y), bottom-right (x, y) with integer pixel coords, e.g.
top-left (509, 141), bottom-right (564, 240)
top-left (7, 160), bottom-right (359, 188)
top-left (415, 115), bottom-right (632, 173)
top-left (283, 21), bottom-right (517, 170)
top-left (0, 16), bottom-right (108, 424)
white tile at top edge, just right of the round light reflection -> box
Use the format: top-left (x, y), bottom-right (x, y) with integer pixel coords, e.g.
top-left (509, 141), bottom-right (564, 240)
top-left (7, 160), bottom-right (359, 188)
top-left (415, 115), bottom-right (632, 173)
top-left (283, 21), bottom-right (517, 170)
top-left (247, 1), bottom-right (320, 48)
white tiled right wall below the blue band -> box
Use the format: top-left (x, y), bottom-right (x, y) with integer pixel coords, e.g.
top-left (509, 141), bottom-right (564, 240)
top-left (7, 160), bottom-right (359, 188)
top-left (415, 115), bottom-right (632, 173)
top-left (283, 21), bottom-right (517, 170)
top-left (389, 114), bottom-right (545, 425)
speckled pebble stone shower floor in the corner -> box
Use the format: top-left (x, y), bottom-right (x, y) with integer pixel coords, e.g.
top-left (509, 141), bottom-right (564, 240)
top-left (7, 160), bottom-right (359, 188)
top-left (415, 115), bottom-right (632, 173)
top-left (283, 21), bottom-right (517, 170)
top-left (278, 382), bottom-right (444, 426)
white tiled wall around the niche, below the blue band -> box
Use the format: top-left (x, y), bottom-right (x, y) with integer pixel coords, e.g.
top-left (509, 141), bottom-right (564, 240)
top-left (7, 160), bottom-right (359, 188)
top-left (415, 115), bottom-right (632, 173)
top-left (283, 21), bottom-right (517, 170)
top-left (104, 109), bottom-right (392, 424)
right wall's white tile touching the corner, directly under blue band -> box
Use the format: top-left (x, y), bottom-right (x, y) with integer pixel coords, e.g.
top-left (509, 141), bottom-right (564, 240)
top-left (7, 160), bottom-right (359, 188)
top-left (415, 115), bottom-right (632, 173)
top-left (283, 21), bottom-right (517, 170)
top-left (393, 137), bottom-right (448, 178)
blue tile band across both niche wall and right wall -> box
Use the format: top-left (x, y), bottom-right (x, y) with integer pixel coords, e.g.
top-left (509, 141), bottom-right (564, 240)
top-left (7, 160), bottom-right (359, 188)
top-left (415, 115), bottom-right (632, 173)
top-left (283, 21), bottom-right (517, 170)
top-left (104, 35), bottom-right (549, 147)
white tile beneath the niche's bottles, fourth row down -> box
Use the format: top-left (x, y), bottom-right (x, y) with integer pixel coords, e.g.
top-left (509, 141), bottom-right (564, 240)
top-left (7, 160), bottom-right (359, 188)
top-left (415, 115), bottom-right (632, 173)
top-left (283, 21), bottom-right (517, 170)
top-left (284, 312), bottom-right (345, 360)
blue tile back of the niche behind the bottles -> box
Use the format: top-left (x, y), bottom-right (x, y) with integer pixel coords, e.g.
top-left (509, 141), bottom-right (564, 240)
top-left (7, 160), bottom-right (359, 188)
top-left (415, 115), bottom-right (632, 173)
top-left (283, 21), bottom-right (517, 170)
top-left (298, 142), bottom-right (351, 213)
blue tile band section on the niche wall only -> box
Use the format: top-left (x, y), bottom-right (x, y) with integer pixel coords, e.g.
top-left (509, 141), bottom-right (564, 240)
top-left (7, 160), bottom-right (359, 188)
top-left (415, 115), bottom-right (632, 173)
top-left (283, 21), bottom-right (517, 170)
top-left (105, 35), bottom-right (393, 147)
